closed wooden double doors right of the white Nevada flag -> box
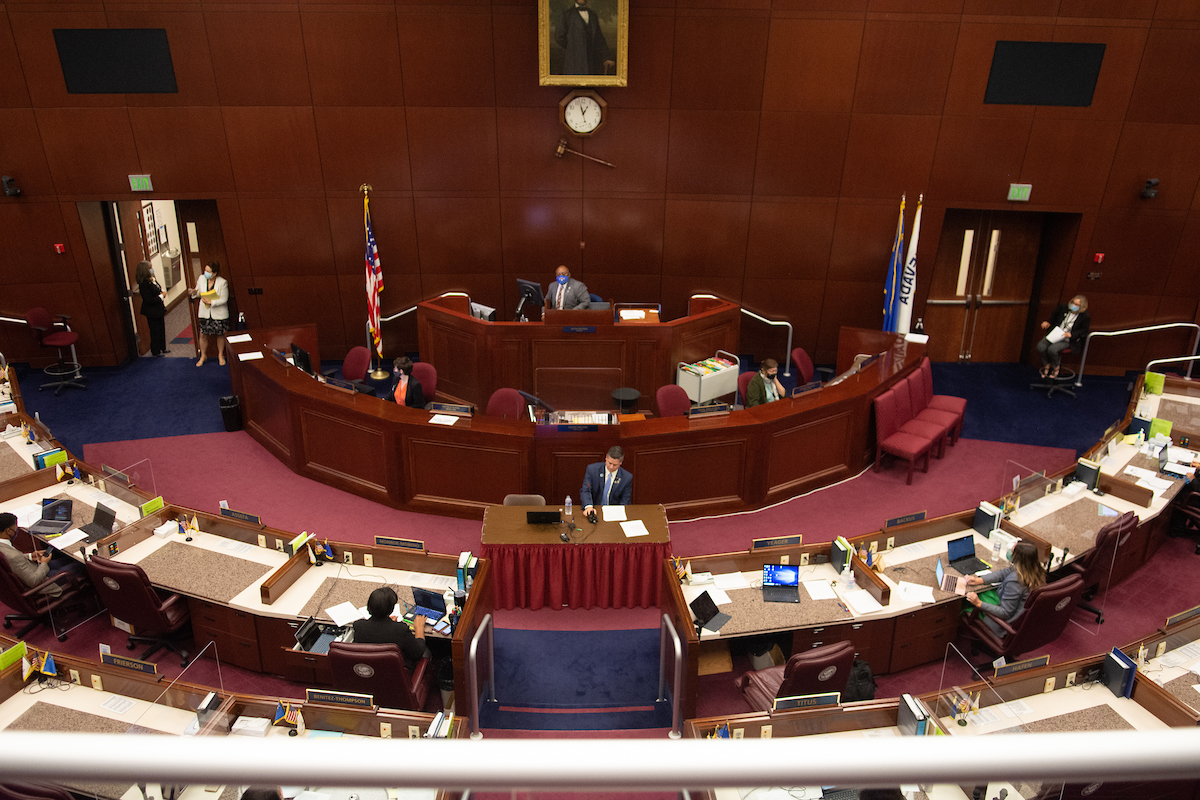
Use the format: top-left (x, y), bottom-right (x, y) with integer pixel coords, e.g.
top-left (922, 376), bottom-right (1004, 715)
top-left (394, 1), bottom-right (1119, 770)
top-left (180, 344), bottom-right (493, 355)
top-left (924, 209), bottom-right (1043, 362)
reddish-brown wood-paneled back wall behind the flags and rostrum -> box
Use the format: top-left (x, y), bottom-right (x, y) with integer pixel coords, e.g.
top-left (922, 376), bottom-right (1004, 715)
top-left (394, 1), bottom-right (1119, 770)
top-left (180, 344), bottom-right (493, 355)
top-left (0, 0), bottom-right (1200, 367)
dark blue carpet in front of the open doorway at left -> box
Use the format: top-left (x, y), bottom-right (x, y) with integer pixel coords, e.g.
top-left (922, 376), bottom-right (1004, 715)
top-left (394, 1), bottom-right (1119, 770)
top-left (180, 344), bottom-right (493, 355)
top-left (18, 357), bottom-right (230, 453)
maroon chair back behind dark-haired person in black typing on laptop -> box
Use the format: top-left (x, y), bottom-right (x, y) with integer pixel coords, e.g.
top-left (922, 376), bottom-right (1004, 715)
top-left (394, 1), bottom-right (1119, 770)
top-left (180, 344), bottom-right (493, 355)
top-left (329, 642), bottom-right (433, 711)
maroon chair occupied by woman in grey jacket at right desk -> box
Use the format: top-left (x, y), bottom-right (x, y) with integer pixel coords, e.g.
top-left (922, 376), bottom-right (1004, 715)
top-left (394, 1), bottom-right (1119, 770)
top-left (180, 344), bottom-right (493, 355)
top-left (961, 575), bottom-right (1084, 661)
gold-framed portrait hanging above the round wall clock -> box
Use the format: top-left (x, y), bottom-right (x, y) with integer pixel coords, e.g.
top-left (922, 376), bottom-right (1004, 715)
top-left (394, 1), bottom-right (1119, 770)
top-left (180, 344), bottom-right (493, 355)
top-left (538, 0), bottom-right (629, 86)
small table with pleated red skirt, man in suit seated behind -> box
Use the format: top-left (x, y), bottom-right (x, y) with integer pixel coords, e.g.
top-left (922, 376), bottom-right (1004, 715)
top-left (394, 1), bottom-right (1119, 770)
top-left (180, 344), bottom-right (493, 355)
top-left (482, 506), bottom-right (671, 609)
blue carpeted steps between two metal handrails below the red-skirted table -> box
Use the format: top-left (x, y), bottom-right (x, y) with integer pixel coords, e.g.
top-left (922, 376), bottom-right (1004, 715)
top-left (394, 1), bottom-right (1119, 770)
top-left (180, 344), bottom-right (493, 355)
top-left (480, 628), bottom-right (671, 730)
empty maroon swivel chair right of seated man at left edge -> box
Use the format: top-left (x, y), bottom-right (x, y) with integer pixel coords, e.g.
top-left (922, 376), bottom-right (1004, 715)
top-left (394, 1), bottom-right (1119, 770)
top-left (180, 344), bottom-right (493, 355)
top-left (88, 555), bottom-right (191, 667)
